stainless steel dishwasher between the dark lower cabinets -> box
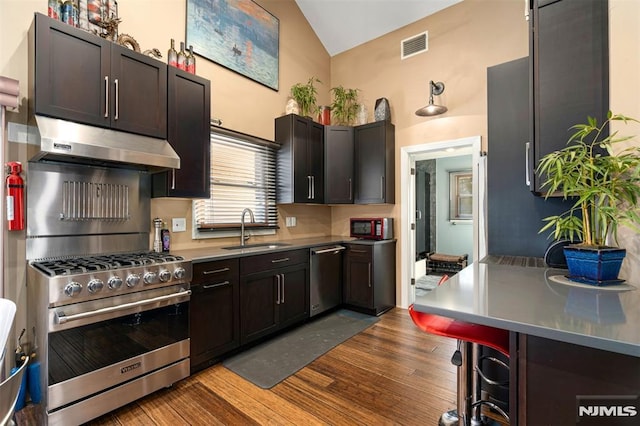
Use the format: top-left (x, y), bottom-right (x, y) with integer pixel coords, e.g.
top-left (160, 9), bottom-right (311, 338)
top-left (309, 245), bottom-right (345, 316)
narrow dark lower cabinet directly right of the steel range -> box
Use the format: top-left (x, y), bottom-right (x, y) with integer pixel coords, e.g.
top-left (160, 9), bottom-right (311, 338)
top-left (190, 259), bottom-right (240, 373)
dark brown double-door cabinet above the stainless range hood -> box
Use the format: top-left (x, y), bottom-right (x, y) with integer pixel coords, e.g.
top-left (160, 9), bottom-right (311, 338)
top-left (29, 13), bottom-right (167, 139)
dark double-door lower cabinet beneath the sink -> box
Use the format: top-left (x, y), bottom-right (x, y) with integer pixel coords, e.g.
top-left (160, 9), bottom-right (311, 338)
top-left (240, 250), bottom-right (309, 344)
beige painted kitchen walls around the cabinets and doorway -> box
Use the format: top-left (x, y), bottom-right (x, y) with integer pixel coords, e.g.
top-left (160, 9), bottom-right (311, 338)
top-left (0, 0), bottom-right (640, 332)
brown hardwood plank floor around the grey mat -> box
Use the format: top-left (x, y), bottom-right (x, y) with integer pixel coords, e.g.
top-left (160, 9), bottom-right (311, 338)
top-left (17, 308), bottom-right (456, 426)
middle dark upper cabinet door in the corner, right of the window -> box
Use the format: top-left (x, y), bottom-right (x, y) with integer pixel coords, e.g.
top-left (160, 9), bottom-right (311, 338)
top-left (324, 126), bottom-right (355, 204)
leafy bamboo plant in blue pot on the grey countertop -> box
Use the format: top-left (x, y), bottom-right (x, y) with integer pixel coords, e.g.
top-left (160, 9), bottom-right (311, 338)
top-left (537, 112), bottom-right (640, 285)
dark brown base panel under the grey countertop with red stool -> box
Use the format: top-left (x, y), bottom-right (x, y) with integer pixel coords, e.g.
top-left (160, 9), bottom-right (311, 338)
top-left (510, 334), bottom-right (640, 425)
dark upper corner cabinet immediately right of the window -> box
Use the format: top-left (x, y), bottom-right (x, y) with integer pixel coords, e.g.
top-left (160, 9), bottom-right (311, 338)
top-left (275, 114), bottom-right (324, 204)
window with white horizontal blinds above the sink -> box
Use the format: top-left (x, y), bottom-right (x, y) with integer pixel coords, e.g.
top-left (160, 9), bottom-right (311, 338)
top-left (192, 127), bottom-right (278, 235)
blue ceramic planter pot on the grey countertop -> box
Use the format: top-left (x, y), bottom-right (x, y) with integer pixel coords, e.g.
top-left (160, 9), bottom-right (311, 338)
top-left (564, 245), bottom-right (627, 286)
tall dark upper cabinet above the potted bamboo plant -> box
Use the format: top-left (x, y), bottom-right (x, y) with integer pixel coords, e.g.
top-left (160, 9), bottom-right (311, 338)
top-left (523, 0), bottom-right (609, 194)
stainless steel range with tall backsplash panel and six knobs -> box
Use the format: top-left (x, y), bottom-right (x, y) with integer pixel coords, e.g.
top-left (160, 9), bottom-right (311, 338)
top-left (26, 163), bottom-right (192, 425)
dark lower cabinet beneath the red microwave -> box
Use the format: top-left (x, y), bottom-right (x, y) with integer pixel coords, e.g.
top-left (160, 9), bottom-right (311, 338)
top-left (343, 240), bottom-right (396, 315)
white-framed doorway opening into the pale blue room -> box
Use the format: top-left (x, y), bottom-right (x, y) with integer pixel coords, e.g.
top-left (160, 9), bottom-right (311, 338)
top-left (400, 136), bottom-right (486, 307)
